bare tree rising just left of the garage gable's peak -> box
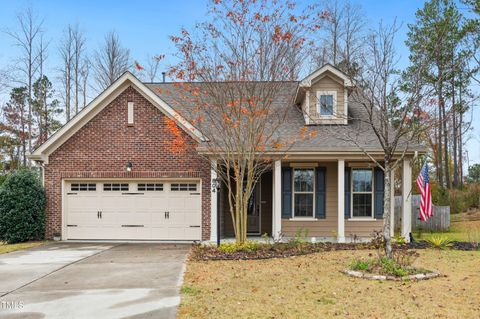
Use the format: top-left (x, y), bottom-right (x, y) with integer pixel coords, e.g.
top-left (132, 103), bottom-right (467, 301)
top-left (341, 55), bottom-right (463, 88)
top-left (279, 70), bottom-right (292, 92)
top-left (93, 31), bottom-right (130, 90)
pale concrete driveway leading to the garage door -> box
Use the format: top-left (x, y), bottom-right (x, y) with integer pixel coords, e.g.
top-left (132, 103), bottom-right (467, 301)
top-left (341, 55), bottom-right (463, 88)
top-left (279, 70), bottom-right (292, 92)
top-left (0, 243), bottom-right (189, 319)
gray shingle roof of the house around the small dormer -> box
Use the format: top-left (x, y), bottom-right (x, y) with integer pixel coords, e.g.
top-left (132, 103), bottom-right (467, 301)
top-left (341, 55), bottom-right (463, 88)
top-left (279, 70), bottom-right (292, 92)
top-left (145, 81), bottom-right (424, 152)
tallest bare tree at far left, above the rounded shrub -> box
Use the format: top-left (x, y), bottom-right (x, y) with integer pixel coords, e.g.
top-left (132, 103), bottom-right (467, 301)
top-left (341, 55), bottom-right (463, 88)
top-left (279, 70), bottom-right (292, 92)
top-left (6, 8), bottom-right (43, 157)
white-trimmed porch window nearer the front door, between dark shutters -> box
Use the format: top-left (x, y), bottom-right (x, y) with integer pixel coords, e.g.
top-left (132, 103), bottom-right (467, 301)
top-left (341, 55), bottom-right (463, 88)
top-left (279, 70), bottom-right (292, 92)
top-left (293, 168), bottom-right (315, 218)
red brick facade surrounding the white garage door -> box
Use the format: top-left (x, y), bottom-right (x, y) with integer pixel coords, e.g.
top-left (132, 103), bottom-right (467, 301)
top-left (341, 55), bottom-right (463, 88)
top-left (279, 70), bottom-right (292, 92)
top-left (44, 87), bottom-right (210, 240)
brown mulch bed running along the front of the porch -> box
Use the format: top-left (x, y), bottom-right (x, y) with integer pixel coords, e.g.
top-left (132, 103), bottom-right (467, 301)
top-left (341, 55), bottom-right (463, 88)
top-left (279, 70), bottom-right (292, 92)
top-left (190, 241), bottom-right (478, 261)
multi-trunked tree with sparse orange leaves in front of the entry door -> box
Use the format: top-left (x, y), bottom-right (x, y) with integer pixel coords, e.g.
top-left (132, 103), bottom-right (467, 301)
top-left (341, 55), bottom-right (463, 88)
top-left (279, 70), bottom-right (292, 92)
top-left (170, 0), bottom-right (321, 243)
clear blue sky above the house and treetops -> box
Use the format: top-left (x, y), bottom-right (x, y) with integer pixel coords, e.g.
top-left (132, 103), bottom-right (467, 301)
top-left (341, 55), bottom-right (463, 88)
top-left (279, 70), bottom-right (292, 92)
top-left (0, 0), bottom-right (480, 163)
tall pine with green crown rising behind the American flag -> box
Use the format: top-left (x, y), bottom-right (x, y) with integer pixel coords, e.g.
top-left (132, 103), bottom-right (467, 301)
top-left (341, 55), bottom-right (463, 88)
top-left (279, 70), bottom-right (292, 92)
top-left (406, 0), bottom-right (467, 188)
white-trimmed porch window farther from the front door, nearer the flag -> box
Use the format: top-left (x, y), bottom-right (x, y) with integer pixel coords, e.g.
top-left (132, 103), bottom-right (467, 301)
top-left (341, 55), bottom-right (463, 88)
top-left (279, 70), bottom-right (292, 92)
top-left (352, 169), bottom-right (373, 218)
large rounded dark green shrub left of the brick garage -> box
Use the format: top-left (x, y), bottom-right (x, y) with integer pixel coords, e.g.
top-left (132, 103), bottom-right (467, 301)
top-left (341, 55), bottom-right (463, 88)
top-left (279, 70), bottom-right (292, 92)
top-left (0, 169), bottom-right (46, 243)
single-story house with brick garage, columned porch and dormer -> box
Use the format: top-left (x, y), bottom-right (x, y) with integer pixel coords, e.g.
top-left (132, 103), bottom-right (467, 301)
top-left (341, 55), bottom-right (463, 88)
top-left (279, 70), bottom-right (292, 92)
top-left (30, 65), bottom-right (423, 242)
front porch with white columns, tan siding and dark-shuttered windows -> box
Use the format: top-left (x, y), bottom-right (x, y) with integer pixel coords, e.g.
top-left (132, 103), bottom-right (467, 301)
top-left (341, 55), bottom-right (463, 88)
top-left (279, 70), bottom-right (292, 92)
top-left (210, 158), bottom-right (412, 242)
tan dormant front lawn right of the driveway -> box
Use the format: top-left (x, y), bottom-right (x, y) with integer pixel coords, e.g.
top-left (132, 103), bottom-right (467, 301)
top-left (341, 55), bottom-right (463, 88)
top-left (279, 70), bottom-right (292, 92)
top-left (178, 250), bottom-right (480, 318)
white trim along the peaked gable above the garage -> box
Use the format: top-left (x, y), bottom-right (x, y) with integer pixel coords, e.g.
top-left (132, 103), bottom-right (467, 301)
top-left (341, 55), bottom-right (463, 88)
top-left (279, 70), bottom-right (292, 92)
top-left (29, 72), bottom-right (205, 163)
